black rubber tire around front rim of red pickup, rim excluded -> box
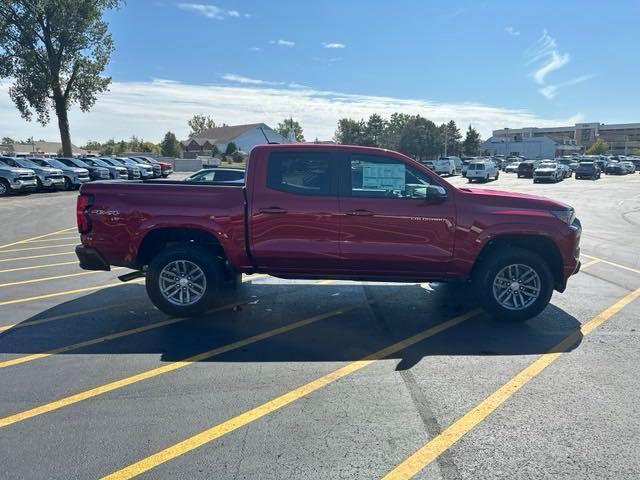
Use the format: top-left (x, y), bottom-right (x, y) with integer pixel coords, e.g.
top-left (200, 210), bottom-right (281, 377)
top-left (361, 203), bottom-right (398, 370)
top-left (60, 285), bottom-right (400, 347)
top-left (473, 247), bottom-right (553, 322)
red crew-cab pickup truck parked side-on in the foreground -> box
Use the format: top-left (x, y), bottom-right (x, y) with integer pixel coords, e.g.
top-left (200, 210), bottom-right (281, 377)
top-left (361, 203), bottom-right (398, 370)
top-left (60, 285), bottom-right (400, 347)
top-left (76, 144), bottom-right (582, 320)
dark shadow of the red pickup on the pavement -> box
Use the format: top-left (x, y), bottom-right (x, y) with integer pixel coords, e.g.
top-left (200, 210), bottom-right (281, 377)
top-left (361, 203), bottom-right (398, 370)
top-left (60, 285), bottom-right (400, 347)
top-left (0, 281), bottom-right (582, 369)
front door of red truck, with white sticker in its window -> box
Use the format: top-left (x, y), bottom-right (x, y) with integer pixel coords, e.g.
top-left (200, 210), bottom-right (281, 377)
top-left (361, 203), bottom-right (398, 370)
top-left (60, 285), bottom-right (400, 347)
top-left (340, 152), bottom-right (455, 277)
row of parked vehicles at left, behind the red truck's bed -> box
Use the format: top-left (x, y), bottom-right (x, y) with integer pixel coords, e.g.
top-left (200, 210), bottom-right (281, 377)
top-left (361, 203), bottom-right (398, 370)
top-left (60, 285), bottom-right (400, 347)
top-left (0, 156), bottom-right (173, 196)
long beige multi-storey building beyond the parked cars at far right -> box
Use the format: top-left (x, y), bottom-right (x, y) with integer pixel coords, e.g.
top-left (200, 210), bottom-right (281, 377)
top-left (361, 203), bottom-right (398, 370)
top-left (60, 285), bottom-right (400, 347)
top-left (493, 122), bottom-right (640, 155)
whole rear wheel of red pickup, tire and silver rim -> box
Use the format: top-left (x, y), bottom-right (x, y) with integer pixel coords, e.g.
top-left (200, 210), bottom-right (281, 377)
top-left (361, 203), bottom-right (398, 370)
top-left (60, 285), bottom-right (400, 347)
top-left (146, 244), bottom-right (224, 317)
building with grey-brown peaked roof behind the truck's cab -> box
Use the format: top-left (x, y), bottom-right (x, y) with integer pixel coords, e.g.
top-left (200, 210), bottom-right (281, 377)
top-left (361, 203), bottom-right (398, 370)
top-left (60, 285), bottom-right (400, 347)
top-left (180, 123), bottom-right (287, 158)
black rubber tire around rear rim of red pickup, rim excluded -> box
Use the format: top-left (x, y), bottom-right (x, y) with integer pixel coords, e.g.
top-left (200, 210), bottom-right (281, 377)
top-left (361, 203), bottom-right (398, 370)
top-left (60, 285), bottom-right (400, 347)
top-left (146, 244), bottom-right (224, 317)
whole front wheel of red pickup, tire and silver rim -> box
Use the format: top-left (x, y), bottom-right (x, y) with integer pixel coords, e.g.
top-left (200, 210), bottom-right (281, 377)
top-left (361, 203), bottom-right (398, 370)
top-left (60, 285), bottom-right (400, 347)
top-left (473, 247), bottom-right (553, 321)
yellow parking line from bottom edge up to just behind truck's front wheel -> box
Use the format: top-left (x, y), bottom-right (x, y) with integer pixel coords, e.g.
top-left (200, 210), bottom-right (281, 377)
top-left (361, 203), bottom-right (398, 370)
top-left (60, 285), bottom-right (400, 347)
top-left (103, 310), bottom-right (478, 480)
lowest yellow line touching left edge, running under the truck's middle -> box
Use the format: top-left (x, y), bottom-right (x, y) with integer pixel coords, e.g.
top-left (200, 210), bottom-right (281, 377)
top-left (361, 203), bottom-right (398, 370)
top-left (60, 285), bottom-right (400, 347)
top-left (0, 300), bottom-right (356, 428)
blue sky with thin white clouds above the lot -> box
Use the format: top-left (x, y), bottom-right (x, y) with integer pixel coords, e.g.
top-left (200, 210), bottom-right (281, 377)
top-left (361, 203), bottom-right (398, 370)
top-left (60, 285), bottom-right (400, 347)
top-left (0, 0), bottom-right (640, 143)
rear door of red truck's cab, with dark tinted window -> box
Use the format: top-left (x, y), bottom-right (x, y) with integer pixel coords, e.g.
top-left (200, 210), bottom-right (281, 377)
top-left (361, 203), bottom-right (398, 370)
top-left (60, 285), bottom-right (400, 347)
top-left (249, 148), bottom-right (340, 273)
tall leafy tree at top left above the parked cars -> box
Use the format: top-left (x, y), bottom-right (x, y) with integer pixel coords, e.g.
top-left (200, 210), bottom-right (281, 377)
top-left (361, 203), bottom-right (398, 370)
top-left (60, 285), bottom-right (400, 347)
top-left (0, 0), bottom-right (120, 156)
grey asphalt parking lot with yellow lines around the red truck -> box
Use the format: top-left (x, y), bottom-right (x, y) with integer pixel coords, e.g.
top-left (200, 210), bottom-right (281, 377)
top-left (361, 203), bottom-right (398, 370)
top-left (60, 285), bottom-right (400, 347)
top-left (0, 173), bottom-right (640, 480)
